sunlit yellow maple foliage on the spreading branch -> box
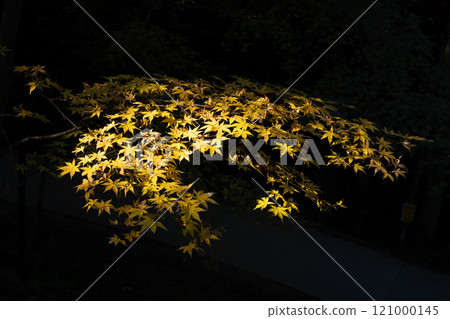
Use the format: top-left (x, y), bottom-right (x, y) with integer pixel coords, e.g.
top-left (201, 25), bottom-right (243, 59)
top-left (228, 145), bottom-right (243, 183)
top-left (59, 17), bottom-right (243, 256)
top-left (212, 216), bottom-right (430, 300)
top-left (12, 66), bottom-right (421, 255)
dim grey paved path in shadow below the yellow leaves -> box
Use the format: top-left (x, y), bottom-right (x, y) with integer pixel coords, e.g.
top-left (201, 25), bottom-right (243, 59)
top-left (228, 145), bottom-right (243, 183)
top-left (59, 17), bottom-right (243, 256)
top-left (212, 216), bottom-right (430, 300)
top-left (203, 206), bottom-right (450, 300)
